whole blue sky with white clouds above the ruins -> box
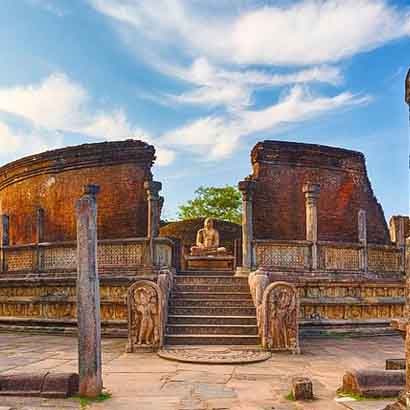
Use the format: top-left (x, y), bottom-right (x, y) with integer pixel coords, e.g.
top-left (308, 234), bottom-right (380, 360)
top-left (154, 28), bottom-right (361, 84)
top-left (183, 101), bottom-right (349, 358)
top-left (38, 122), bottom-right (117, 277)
top-left (0, 0), bottom-right (410, 218)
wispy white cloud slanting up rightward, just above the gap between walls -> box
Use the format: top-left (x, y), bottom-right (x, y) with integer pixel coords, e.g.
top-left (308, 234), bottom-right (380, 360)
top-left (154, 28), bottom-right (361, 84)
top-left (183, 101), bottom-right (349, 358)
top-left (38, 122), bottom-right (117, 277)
top-left (163, 86), bottom-right (369, 160)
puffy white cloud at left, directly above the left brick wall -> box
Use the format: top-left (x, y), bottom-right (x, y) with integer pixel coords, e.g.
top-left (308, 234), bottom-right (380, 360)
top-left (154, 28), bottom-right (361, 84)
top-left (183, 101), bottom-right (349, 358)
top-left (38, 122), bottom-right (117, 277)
top-left (0, 73), bottom-right (174, 165)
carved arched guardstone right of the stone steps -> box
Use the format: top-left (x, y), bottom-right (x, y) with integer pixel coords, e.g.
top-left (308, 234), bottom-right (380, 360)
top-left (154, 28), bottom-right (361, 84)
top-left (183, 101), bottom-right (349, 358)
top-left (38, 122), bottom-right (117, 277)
top-left (262, 282), bottom-right (300, 353)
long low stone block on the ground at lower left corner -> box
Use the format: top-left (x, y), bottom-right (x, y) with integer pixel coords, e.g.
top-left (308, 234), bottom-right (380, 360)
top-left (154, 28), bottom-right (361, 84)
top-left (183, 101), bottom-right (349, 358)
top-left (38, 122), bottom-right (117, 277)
top-left (0, 372), bottom-right (79, 398)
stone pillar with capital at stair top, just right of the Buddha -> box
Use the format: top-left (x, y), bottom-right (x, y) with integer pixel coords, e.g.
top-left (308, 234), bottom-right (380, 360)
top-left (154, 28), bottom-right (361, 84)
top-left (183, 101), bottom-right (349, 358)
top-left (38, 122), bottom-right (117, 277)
top-left (237, 180), bottom-right (256, 275)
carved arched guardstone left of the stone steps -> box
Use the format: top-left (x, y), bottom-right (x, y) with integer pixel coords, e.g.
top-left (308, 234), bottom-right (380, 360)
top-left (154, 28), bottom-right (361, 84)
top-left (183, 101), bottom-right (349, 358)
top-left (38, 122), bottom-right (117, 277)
top-left (127, 280), bottom-right (164, 353)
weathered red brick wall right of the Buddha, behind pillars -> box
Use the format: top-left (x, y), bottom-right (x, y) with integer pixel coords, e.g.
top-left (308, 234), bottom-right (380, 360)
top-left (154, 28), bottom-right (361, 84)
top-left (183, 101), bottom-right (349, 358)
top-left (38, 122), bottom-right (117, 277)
top-left (251, 141), bottom-right (390, 243)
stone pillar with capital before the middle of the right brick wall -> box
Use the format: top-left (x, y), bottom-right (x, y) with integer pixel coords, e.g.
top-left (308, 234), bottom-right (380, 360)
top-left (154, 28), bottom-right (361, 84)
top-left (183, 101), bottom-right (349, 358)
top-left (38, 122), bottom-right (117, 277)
top-left (303, 182), bottom-right (320, 270)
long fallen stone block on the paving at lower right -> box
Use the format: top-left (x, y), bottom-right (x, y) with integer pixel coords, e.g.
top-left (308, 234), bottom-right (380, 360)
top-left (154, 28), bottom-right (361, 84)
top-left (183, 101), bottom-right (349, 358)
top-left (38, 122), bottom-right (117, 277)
top-left (342, 370), bottom-right (406, 397)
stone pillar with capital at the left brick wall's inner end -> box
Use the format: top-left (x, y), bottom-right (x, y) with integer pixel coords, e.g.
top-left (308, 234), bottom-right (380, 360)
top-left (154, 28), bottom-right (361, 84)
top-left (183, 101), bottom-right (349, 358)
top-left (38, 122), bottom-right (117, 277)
top-left (144, 181), bottom-right (162, 265)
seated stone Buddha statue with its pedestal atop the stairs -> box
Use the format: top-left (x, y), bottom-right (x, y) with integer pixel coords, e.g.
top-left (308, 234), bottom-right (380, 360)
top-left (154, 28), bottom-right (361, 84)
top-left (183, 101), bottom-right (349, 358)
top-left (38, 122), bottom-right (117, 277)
top-left (185, 218), bottom-right (235, 271)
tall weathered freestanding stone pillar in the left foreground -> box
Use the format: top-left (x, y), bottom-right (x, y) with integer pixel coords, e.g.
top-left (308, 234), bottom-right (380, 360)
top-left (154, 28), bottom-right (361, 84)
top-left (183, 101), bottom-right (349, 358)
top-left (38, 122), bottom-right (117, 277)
top-left (76, 185), bottom-right (102, 397)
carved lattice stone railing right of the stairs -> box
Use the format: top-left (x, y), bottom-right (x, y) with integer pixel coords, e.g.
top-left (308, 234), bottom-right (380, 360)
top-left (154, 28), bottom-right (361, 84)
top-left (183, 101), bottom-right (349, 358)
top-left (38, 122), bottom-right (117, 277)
top-left (253, 239), bottom-right (405, 274)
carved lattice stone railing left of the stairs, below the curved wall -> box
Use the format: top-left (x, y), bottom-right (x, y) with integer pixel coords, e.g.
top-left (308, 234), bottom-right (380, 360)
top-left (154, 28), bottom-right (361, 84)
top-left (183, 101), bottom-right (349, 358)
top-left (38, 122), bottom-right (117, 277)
top-left (1, 238), bottom-right (174, 273)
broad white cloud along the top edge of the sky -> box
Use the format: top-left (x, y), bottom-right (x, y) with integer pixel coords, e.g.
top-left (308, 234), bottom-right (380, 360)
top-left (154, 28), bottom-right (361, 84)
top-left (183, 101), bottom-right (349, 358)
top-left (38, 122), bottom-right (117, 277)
top-left (90, 0), bottom-right (410, 65)
